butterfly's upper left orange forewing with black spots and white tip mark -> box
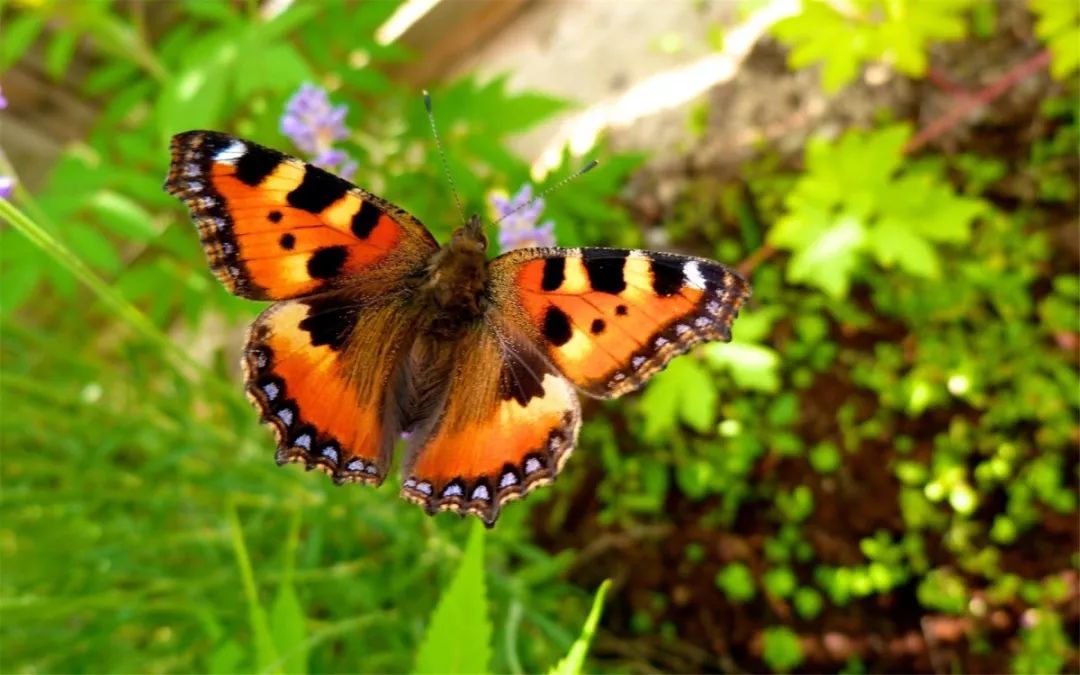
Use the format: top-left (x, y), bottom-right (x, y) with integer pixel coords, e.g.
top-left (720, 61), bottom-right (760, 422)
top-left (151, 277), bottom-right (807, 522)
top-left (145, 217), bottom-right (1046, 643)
top-left (165, 131), bottom-right (437, 300)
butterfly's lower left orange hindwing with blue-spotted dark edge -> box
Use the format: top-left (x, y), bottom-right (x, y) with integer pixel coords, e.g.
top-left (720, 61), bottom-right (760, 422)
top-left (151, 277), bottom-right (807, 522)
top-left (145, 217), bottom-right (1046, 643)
top-left (244, 294), bottom-right (415, 485)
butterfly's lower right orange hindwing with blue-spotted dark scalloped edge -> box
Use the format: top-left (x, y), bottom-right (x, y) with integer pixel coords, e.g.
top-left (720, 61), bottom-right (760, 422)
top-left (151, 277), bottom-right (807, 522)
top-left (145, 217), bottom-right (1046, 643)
top-left (402, 324), bottom-right (581, 526)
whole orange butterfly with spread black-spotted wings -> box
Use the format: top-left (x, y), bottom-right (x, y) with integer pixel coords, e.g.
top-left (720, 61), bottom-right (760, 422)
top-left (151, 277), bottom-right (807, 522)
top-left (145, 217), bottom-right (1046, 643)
top-left (165, 131), bottom-right (751, 526)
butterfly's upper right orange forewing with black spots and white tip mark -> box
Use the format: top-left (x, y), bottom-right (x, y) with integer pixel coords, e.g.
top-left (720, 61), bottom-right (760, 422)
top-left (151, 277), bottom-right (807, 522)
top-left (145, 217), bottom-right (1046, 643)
top-left (489, 248), bottom-right (750, 399)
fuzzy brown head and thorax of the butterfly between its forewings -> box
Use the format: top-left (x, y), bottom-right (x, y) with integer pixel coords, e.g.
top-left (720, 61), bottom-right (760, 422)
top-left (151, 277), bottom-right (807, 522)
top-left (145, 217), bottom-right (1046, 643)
top-left (420, 216), bottom-right (487, 340)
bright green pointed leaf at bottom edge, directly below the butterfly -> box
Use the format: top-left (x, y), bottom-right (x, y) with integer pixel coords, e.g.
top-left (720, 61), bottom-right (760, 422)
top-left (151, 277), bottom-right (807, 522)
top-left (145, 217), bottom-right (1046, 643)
top-left (414, 519), bottom-right (491, 673)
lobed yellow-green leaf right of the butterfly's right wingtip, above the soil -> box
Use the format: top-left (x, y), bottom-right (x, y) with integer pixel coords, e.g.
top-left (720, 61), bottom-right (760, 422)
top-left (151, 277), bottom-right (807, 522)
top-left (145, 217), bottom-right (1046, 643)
top-left (768, 125), bottom-right (986, 298)
